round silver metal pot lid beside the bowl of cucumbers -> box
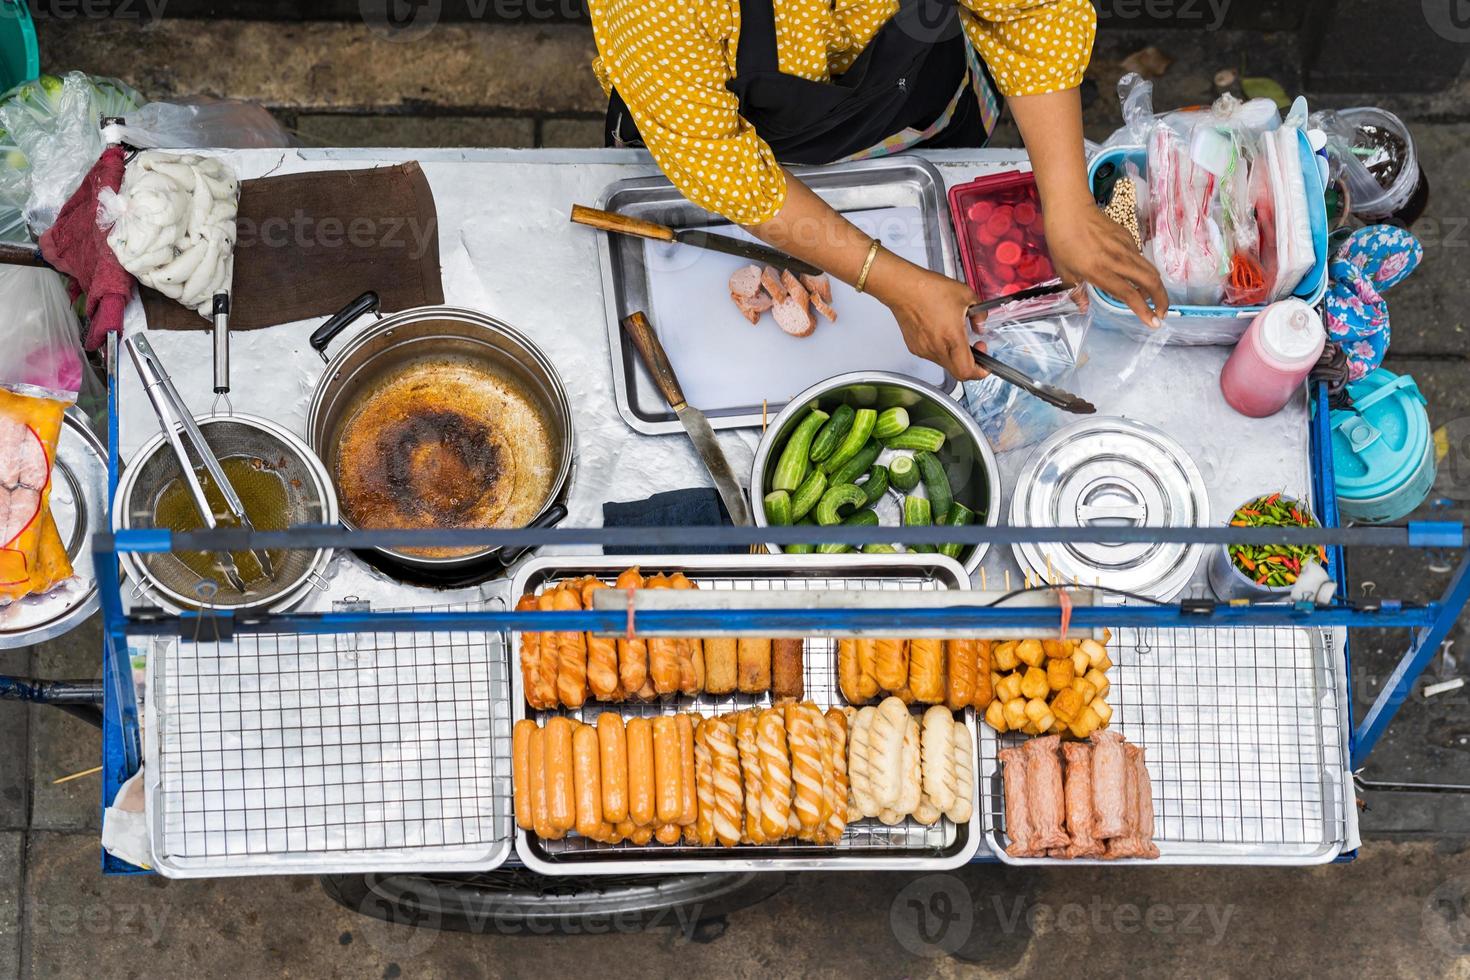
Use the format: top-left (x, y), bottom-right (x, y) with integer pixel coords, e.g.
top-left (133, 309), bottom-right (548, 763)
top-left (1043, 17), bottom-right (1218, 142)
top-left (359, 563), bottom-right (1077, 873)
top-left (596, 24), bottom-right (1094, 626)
top-left (1010, 417), bottom-right (1210, 599)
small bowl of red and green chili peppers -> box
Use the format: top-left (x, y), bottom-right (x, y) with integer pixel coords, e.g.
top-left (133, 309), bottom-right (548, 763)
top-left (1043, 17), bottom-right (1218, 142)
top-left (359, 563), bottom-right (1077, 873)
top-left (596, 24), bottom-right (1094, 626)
top-left (1210, 492), bottom-right (1327, 601)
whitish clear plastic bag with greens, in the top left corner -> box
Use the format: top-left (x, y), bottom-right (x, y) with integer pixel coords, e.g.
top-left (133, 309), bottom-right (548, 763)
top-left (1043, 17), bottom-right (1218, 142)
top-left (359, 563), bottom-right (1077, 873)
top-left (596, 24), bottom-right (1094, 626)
top-left (0, 72), bottom-right (143, 235)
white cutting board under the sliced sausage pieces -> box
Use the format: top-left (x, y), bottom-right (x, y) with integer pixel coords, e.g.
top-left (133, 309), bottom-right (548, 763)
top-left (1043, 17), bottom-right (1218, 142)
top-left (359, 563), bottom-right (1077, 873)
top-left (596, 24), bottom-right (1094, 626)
top-left (644, 207), bottom-right (944, 413)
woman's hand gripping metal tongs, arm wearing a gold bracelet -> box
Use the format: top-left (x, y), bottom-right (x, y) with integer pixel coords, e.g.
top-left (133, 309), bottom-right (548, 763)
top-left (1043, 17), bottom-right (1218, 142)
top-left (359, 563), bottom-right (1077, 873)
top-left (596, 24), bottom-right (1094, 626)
top-left (869, 251), bottom-right (985, 381)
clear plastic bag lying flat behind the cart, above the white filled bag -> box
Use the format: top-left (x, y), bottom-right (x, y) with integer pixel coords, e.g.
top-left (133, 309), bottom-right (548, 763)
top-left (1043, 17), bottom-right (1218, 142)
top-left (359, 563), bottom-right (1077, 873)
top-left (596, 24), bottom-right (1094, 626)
top-left (103, 96), bottom-right (294, 148)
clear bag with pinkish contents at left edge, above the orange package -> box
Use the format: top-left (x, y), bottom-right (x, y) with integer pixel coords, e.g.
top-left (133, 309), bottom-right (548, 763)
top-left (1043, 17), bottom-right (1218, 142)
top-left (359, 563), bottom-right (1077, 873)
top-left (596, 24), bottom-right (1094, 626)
top-left (0, 266), bottom-right (87, 403)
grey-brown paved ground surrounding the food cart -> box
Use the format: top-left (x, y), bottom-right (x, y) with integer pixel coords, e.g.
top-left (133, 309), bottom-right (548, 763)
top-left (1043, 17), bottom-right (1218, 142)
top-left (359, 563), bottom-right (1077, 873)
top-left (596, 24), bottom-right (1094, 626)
top-left (11, 9), bottom-right (1470, 979)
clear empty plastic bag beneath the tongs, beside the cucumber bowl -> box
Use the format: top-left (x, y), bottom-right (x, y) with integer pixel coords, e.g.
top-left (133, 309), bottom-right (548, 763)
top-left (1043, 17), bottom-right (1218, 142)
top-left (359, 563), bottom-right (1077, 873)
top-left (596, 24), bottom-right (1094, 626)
top-left (964, 282), bottom-right (1092, 453)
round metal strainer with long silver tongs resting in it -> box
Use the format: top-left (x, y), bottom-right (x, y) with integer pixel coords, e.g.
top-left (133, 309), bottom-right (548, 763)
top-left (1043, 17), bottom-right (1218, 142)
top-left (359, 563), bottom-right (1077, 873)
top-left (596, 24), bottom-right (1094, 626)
top-left (113, 414), bottom-right (337, 613)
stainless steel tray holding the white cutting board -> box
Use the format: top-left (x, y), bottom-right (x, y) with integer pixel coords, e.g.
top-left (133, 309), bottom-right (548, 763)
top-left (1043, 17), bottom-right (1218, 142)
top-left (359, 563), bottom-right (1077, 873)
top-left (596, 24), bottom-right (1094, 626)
top-left (597, 154), bottom-right (961, 435)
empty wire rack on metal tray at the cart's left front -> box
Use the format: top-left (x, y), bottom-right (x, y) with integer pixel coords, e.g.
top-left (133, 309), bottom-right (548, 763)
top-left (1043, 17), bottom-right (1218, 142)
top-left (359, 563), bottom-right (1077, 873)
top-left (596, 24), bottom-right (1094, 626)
top-left (146, 607), bottom-right (512, 877)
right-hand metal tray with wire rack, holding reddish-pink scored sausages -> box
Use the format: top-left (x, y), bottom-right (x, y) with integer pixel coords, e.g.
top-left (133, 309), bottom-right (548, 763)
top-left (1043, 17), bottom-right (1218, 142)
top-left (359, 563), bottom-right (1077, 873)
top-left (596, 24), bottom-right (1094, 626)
top-left (978, 627), bottom-right (1352, 865)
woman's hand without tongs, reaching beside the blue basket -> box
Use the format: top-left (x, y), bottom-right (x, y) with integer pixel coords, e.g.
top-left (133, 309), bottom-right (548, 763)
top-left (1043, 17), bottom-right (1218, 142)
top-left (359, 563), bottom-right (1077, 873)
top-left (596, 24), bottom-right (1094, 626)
top-left (1044, 198), bottom-right (1169, 328)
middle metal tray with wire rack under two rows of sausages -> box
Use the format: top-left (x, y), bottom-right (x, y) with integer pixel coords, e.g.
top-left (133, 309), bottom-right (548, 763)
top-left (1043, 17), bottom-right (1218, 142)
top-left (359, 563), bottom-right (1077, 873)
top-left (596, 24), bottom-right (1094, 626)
top-left (512, 558), bottom-right (979, 874)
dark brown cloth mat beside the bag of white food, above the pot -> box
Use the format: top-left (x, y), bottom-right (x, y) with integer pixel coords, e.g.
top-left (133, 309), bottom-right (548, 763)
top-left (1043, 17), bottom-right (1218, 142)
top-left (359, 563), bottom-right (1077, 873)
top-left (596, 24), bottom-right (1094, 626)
top-left (141, 163), bottom-right (444, 331)
